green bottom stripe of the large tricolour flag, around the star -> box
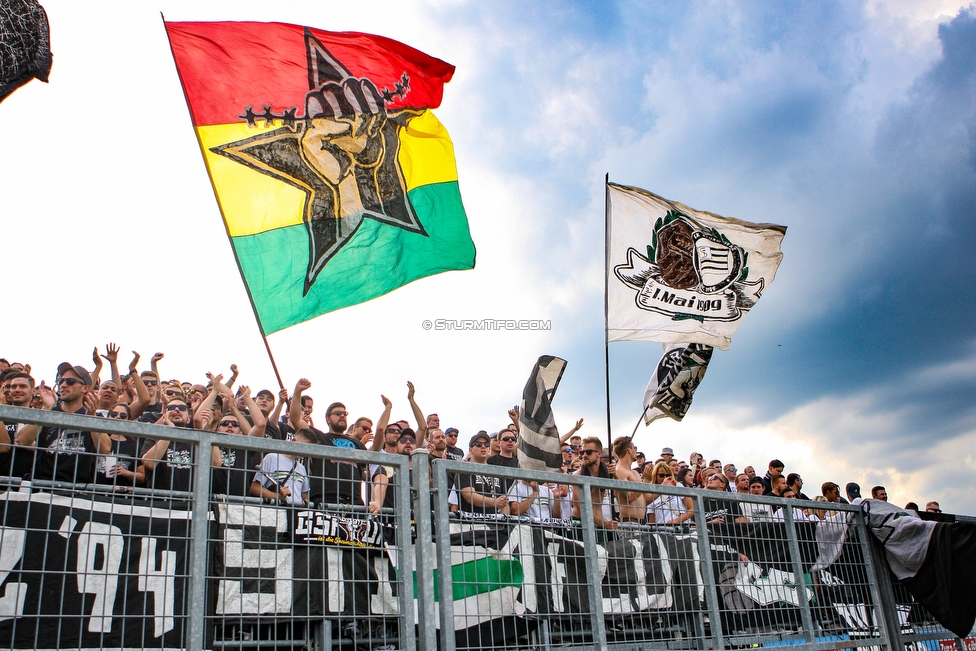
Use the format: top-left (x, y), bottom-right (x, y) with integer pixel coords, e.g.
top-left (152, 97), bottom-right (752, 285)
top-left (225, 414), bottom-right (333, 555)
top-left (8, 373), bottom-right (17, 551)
top-left (231, 181), bottom-right (475, 335)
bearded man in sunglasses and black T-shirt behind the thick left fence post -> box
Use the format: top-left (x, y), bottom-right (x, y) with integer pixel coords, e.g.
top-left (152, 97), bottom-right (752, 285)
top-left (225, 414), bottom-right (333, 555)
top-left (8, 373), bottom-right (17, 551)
top-left (142, 398), bottom-right (223, 491)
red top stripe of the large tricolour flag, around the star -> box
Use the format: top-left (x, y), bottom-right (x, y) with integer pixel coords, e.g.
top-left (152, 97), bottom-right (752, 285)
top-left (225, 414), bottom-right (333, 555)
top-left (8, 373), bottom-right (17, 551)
top-left (166, 22), bottom-right (454, 126)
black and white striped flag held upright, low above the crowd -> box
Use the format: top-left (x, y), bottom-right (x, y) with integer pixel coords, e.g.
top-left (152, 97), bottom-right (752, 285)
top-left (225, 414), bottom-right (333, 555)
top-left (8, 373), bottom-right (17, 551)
top-left (518, 355), bottom-right (566, 471)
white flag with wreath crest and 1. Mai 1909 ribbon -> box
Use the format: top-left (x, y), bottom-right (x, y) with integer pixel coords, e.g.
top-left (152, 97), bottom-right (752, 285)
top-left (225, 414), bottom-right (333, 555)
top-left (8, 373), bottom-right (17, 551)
top-left (607, 183), bottom-right (786, 350)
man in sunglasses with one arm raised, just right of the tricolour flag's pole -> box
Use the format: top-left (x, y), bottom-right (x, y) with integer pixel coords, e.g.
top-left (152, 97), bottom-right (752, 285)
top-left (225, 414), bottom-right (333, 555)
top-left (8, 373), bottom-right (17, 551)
top-left (289, 378), bottom-right (366, 506)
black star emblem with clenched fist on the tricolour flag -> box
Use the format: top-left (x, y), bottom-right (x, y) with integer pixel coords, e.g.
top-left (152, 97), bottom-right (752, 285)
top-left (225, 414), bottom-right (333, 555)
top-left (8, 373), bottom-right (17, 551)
top-left (211, 29), bottom-right (427, 295)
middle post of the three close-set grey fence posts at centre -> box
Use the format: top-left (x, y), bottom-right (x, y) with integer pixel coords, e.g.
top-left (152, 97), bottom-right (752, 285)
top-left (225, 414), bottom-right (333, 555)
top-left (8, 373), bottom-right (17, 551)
top-left (410, 449), bottom-right (443, 651)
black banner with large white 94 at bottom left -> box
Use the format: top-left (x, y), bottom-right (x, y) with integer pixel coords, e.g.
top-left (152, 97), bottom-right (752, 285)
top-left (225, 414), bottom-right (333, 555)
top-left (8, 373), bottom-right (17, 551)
top-left (0, 492), bottom-right (190, 649)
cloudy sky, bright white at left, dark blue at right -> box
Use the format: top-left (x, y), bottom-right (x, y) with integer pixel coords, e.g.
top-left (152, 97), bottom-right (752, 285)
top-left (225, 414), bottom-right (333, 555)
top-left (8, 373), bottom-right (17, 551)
top-left (0, 0), bottom-right (976, 513)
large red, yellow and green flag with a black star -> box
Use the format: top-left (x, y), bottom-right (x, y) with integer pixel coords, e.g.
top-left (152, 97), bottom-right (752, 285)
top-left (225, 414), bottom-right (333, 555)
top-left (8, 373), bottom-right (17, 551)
top-left (166, 23), bottom-right (475, 335)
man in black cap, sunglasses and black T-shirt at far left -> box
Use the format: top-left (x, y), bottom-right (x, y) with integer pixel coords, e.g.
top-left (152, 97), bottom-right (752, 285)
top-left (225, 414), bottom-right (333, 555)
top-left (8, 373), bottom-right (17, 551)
top-left (18, 362), bottom-right (112, 484)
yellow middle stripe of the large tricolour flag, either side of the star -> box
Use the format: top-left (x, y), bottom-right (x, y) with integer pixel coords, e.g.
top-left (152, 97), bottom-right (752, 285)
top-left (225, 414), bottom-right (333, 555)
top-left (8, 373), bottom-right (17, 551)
top-left (197, 111), bottom-right (457, 237)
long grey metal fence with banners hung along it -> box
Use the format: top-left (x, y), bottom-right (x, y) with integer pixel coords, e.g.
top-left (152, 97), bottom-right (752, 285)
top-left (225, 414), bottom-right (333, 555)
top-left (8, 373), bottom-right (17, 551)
top-left (0, 406), bottom-right (976, 651)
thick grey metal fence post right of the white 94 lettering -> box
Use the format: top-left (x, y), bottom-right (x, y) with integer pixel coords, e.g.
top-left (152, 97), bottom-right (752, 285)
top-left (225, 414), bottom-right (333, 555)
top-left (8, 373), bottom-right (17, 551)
top-left (186, 431), bottom-right (213, 651)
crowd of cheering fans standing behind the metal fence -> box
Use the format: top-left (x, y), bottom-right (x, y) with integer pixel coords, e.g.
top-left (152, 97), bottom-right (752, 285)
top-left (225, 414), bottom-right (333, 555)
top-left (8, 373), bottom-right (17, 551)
top-left (0, 352), bottom-right (941, 529)
